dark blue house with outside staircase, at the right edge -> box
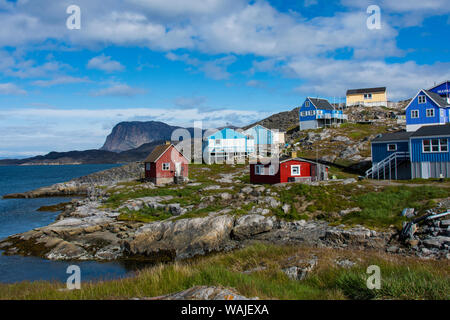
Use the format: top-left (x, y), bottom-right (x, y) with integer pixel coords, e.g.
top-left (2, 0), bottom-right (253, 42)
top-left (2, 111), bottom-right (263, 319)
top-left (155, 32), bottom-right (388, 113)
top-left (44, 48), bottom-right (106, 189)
top-left (366, 123), bottom-right (450, 180)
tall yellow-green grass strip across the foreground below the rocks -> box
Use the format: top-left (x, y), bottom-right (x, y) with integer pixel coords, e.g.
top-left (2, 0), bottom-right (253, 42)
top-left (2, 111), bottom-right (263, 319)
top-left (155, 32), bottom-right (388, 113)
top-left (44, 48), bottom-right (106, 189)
top-left (0, 244), bottom-right (450, 300)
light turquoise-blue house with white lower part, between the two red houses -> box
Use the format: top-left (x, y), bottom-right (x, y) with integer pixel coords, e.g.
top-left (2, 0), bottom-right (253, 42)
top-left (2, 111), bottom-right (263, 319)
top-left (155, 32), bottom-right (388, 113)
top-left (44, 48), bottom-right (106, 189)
top-left (202, 128), bottom-right (255, 164)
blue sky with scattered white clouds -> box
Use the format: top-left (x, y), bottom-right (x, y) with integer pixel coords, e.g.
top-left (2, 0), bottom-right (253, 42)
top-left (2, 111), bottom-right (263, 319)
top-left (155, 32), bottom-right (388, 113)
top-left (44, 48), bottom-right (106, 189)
top-left (0, 0), bottom-right (450, 158)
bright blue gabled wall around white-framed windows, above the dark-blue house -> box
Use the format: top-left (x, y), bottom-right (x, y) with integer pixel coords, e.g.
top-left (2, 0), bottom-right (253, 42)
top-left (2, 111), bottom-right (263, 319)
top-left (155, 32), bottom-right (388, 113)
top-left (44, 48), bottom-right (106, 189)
top-left (406, 92), bottom-right (448, 132)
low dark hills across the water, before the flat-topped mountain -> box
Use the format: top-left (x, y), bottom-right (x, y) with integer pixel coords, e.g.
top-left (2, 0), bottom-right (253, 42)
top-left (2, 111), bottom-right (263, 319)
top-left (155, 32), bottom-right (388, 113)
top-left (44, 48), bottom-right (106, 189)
top-left (0, 141), bottom-right (164, 166)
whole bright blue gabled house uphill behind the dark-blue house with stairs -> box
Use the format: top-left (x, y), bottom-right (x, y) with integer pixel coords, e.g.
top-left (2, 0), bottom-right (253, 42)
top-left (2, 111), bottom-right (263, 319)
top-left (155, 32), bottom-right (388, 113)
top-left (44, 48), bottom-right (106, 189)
top-left (405, 89), bottom-right (450, 132)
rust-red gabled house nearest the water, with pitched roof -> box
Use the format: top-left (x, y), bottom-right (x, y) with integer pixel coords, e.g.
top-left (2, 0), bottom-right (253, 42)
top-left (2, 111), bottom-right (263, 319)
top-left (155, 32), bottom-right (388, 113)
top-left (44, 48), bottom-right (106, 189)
top-left (144, 144), bottom-right (189, 185)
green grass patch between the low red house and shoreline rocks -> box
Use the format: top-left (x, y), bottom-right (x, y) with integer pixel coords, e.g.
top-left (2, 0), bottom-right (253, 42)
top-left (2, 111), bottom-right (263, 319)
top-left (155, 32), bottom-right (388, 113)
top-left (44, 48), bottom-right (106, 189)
top-left (268, 184), bottom-right (450, 229)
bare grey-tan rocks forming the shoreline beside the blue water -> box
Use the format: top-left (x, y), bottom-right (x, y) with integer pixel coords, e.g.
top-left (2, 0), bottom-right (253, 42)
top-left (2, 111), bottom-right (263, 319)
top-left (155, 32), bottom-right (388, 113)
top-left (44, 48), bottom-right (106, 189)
top-left (0, 163), bottom-right (450, 262)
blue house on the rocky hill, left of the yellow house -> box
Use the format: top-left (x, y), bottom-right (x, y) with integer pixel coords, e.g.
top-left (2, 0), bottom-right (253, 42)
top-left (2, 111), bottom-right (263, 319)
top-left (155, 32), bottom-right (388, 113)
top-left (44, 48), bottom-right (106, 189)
top-left (299, 98), bottom-right (347, 130)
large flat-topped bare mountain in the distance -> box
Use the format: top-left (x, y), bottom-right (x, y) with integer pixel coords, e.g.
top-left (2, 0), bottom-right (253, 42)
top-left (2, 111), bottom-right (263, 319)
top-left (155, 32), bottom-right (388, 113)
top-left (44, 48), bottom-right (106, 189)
top-left (100, 121), bottom-right (193, 152)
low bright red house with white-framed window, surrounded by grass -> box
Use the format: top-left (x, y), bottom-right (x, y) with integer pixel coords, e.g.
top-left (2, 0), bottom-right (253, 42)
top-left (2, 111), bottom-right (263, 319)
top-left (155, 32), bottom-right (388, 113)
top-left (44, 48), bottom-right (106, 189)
top-left (250, 158), bottom-right (328, 184)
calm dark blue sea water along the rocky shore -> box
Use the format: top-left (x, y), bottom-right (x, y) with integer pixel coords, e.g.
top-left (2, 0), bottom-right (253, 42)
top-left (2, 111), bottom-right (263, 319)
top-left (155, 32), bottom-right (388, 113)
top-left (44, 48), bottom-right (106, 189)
top-left (0, 164), bottom-right (144, 283)
